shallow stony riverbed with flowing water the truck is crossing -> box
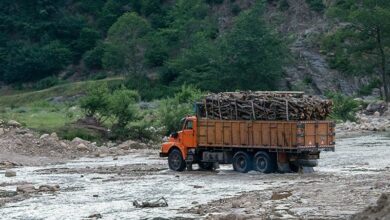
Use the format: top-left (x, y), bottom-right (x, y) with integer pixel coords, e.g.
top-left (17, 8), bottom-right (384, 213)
top-left (0, 131), bottom-right (390, 219)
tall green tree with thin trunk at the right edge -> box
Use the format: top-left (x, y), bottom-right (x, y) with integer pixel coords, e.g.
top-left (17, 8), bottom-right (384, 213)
top-left (327, 0), bottom-right (390, 102)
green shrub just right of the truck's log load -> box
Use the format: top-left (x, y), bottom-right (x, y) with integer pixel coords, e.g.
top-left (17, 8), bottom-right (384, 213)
top-left (327, 93), bottom-right (359, 121)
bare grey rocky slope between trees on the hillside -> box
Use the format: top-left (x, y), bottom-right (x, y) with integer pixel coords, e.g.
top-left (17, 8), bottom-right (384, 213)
top-left (267, 0), bottom-right (363, 95)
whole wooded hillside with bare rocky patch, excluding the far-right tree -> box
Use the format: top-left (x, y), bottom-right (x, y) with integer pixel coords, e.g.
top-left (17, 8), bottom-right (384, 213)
top-left (0, 0), bottom-right (388, 99)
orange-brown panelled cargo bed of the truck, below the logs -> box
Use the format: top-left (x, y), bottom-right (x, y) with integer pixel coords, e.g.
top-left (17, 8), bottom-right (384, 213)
top-left (197, 118), bottom-right (335, 151)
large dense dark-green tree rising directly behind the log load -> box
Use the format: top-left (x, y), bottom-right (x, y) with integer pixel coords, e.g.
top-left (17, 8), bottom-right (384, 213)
top-left (220, 2), bottom-right (286, 90)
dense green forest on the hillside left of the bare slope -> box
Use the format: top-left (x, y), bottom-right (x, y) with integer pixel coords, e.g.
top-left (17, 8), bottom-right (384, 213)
top-left (0, 0), bottom-right (287, 99)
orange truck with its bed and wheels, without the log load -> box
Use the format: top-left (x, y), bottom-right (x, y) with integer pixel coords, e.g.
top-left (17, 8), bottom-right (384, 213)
top-left (160, 116), bottom-right (335, 173)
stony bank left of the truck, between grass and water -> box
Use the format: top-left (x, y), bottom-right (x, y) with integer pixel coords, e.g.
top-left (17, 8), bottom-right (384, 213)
top-left (0, 120), bottom-right (155, 169)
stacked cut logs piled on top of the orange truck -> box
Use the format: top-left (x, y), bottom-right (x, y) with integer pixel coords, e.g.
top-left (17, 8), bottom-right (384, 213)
top-left (196, 91), bottom-right (333, 120)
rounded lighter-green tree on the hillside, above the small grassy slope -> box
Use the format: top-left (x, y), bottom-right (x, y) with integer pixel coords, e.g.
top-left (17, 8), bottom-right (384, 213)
top-left (103, 12), bottom-right (150, 76)
